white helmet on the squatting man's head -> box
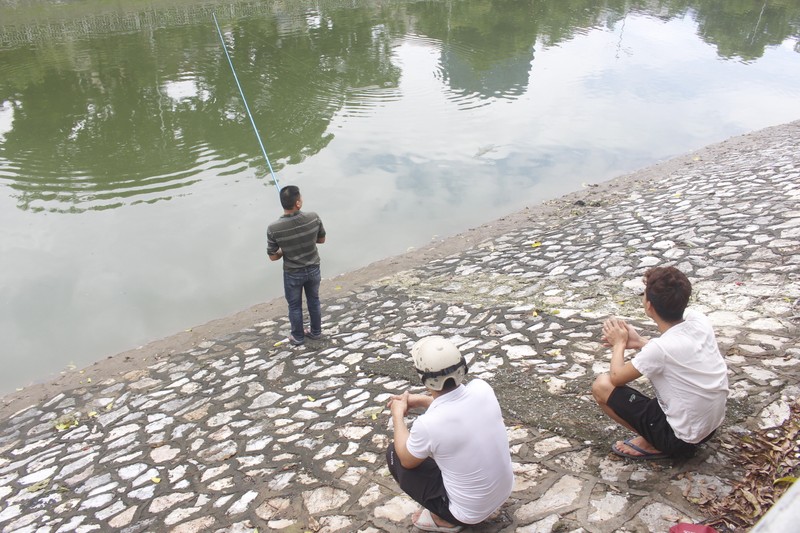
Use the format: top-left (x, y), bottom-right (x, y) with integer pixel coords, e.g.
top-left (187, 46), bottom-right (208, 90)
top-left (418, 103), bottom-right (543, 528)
top-left (411, 335), bottom-right (467, 391)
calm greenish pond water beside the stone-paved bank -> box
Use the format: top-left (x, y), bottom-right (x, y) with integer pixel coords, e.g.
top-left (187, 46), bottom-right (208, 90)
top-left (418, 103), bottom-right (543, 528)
top-left (0, 0), bottom-right (800, 393)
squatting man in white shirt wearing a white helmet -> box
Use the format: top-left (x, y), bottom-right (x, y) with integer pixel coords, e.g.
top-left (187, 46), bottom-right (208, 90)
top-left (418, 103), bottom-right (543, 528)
top-left (386, 336), bottom-right (514, 532)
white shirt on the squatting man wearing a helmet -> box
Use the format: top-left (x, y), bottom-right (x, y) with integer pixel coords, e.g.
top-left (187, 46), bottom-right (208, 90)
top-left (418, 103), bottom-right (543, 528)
top-left (407, 379), bottom-right (514, 524)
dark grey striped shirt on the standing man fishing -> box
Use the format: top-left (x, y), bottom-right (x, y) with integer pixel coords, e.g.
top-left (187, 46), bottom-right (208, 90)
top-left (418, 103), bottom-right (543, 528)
top-left (267, 211), bottom-right (325, 271)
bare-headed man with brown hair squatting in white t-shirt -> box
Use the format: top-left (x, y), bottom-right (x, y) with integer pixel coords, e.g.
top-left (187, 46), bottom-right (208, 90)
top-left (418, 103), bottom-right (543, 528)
top-left (592, 267), bottom-right (728, 459)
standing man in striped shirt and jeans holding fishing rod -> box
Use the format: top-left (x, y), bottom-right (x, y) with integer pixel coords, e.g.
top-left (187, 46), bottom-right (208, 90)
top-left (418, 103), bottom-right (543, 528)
top-left (267, 185), bottom-right (325, 346)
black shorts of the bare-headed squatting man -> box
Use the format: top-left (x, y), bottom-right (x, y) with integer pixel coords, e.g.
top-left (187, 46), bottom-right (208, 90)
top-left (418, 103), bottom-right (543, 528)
top-left (606, 386), bottom-right (714, 456)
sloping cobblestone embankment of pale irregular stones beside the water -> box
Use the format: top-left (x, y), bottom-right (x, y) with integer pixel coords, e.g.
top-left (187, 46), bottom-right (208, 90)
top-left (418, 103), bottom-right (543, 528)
top-left (0, 122), bottom-right (800, 533)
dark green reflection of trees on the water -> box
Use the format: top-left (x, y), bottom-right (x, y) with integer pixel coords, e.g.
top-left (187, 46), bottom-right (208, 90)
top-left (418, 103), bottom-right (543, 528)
top-left (0, 0), bottom-right (800, 212)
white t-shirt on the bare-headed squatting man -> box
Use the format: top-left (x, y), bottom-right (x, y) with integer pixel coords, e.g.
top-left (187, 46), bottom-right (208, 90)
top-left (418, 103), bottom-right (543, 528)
top-left (631, 310), bottom-right (728, 444)
